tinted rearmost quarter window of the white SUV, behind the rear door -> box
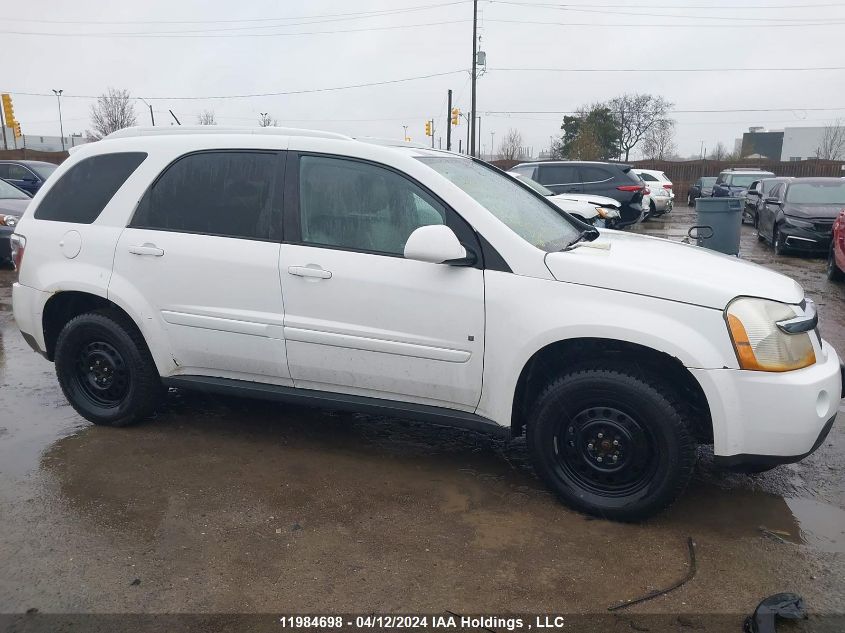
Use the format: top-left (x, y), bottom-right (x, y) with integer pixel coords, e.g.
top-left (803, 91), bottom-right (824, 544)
top-left (35, 152), bottom-right (147, 224)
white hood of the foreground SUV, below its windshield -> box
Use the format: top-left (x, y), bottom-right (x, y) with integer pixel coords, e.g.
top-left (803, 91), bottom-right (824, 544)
top-left (546, 229), bottom-right (804, 310)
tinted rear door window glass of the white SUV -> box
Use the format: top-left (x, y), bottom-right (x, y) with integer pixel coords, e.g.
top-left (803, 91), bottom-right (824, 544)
top-left (130, 151), bottom-right (282, 240)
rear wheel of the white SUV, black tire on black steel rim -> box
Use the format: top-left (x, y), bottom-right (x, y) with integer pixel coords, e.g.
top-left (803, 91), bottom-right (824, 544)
top-left (55, 312), bottom-right (161, 426)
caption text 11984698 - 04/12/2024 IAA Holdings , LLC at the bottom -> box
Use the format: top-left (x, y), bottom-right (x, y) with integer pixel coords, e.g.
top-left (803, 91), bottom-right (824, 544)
top-left (279, 614), bottom-right (565, 631)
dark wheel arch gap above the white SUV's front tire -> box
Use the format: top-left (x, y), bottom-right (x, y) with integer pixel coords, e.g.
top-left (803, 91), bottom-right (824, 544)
top-left (511, 337), bottom-right (713, 444)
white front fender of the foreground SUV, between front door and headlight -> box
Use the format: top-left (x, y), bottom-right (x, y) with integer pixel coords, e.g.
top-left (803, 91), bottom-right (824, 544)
top-left (477, 271), bottom-right (738, 425)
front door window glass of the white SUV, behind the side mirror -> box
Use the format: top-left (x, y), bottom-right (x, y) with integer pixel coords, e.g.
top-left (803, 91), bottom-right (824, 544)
top-left (299, 156), bottom-right (446, 255)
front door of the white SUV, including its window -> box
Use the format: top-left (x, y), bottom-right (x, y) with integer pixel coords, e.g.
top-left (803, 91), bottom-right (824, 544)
top-left (279, 153), bottom-right (484, 411)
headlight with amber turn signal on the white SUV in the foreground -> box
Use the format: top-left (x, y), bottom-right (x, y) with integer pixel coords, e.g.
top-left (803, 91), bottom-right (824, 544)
top-left (725, 297), bottom-right (816, 371)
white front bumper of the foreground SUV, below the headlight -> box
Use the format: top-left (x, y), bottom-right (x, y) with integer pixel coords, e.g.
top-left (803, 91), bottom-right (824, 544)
top-left (690, 343), bottom-right (843, 463)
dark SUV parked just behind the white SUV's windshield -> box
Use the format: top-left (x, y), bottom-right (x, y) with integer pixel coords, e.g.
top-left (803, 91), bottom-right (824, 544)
top-left (510, 160), bottom-right (648, 228)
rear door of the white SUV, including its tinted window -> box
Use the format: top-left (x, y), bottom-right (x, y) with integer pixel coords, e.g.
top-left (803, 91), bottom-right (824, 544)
top-left (109, 150), bottom-right (290, 384)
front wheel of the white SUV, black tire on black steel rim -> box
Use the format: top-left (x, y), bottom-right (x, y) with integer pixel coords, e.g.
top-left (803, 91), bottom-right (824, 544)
top-left (527, 368), bottom-right (695, 521)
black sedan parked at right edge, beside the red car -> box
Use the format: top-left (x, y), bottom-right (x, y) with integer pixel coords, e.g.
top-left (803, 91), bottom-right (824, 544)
top-left (757, 178), bottom-right (845, 255)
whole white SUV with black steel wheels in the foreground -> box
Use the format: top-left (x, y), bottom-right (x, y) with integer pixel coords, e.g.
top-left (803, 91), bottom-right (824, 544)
top-left (9, 128), bottom-right (842, 520)
